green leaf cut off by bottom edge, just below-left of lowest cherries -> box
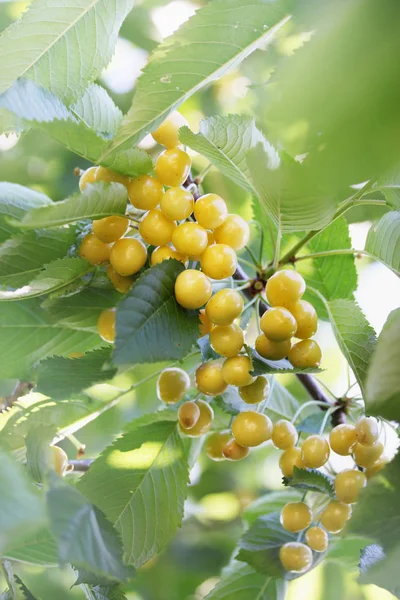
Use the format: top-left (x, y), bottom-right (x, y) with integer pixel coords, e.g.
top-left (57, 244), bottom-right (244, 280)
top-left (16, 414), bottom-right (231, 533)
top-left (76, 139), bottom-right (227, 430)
top-left (206, 560), bottom-right (286, 600)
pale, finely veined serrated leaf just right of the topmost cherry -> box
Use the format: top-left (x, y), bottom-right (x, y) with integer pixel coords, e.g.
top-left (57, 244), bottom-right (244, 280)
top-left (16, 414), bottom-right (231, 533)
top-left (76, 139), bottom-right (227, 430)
top-left (179, 115), bottom-right (279, 196)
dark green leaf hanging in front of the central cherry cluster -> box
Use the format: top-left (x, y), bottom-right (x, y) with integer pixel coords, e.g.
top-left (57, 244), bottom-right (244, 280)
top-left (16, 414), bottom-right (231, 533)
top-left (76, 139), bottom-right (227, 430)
top-left (114, 260), bottom-right (199, 365)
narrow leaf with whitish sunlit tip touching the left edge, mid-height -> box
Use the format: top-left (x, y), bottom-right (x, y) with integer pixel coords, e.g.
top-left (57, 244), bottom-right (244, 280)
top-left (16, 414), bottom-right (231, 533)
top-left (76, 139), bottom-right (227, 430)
top-left (0, 258), bottom-right (93, 301)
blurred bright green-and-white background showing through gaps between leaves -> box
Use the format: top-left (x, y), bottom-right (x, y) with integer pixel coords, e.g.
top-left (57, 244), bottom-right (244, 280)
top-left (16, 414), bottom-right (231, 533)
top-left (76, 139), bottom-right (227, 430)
top-left (0, 0), bottom-right (400, 600)
